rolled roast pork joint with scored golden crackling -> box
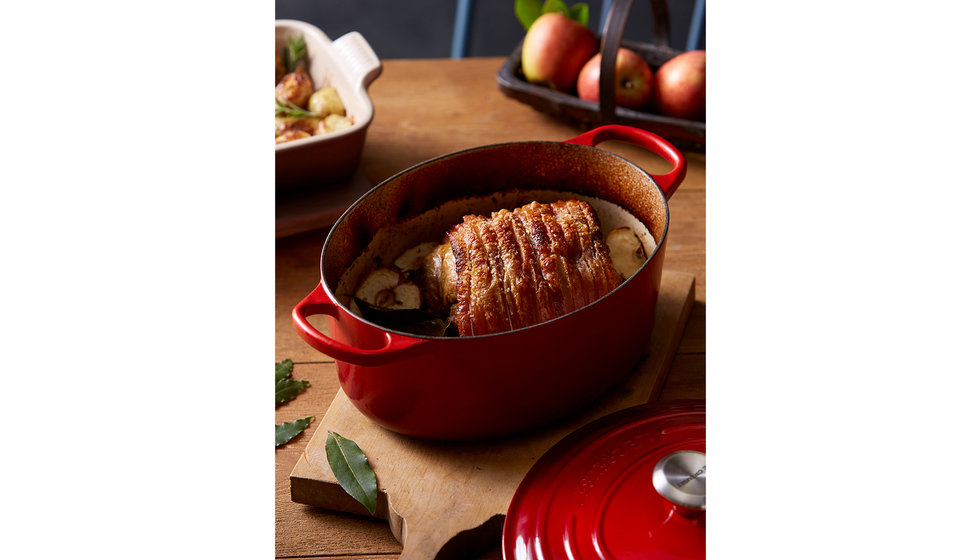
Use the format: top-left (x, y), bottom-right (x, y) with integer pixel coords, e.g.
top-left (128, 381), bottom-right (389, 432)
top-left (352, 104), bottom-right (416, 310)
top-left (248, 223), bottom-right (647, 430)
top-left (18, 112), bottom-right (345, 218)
top-left (423, 200), bottom-right (621, 336)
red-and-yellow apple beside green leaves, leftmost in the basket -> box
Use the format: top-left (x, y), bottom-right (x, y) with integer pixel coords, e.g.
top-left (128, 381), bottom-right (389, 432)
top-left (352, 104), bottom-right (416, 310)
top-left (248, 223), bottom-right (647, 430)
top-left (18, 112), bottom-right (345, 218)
top-left (521, 12), bottom-right (599, 92)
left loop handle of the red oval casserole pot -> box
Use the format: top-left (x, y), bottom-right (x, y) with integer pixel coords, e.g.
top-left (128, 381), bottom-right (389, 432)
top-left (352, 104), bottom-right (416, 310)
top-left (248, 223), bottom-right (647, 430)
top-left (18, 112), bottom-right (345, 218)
top-left (293, 284), bottom-right (428, 366)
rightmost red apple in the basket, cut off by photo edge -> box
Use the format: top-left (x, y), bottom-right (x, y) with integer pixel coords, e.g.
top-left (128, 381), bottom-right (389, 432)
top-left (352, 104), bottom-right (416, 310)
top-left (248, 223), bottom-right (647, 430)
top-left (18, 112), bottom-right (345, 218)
top-left (653, 50), bottom-right (705, 121)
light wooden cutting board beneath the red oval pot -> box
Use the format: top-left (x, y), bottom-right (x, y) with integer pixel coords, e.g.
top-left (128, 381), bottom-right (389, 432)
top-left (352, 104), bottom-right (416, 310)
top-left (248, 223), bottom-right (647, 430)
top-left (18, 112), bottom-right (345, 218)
top-left (289, 271), bottom-right (694, 560)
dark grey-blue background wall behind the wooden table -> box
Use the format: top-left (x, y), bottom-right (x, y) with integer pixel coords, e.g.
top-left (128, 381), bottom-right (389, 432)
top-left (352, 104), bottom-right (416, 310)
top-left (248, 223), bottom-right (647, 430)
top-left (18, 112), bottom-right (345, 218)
top-left (276, 0), bottom-right (705, 58)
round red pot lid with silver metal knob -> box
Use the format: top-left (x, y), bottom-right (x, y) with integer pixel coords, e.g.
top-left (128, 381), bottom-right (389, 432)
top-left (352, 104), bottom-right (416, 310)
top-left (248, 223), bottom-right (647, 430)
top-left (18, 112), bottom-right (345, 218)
top-left (503, 401), bottom-right (706, 560)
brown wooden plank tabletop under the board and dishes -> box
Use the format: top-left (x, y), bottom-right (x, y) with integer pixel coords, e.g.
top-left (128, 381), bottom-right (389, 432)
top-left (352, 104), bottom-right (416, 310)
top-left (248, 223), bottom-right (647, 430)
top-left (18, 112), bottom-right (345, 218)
top-left (275, 57), bottom-right (705, 559)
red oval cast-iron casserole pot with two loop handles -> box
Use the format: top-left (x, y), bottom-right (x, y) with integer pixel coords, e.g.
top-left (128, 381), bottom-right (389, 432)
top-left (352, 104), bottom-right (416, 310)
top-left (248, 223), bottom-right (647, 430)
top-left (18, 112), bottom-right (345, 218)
top-left (293, 125), bottom-right (687, 440)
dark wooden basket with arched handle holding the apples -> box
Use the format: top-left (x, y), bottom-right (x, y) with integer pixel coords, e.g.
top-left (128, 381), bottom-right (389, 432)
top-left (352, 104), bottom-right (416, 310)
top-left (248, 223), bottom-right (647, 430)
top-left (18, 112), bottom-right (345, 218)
top-left (497, 0), bottom-right (705, 152)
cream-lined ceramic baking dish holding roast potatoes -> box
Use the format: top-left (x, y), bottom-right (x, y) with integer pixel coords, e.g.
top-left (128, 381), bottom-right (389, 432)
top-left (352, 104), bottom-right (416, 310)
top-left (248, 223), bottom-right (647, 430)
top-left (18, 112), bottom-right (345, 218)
top-left (278, 20), bottom-right (381, 190)
